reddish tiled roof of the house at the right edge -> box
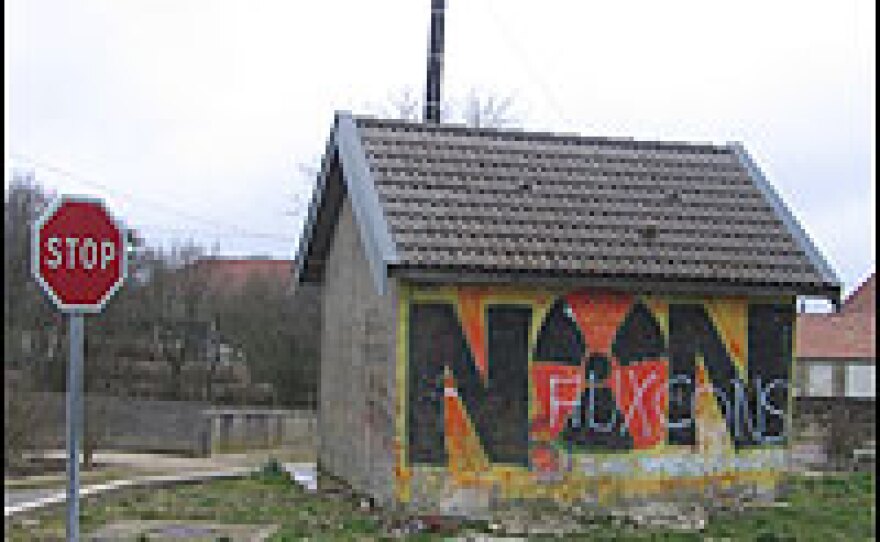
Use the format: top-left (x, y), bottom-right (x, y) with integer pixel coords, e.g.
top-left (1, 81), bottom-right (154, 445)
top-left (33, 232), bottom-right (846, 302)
top-left (795, 275), bottom-right (877, 359)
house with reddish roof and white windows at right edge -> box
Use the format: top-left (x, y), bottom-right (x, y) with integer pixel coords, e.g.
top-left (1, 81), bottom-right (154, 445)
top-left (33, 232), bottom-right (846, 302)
top-left (795, 274), bottom-right (877, 398)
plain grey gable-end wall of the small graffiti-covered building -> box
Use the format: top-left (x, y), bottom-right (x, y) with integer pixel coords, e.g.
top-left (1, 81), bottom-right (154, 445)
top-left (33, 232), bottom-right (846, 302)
top-left (318, 198), bottom-right (396, 501)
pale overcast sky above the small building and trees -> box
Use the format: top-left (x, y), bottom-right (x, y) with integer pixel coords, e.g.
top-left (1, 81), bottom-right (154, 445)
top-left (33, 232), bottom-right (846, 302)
top-left (4, 0), bottom-right (876, 298)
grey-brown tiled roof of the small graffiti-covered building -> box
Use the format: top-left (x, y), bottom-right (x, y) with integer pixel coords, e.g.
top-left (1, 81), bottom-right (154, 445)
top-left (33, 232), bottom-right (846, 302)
top-left (300, 110), bottom-right (839, 296)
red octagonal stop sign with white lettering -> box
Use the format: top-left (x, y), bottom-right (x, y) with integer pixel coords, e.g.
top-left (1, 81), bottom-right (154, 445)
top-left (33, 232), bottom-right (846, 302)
top-left (32, 196), bottom-right (128, 312)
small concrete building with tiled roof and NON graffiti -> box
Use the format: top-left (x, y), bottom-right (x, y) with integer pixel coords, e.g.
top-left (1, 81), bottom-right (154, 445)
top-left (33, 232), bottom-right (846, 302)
top-left (295, 113), bottom-right (840, 513)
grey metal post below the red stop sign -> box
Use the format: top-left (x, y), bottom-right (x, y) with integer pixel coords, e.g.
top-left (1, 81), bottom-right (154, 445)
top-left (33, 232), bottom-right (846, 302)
top-left (67, 312), bottom-right (85, 542)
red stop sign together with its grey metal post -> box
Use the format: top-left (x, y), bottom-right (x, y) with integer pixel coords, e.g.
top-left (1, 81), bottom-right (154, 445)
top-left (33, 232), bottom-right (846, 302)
top-left (31, 196), bottom-right (128, 542)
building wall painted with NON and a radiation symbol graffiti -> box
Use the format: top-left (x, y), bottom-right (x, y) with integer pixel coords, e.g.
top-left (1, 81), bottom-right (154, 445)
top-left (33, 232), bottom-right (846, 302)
top-left (395, 285), bottom-right (794, 512)
